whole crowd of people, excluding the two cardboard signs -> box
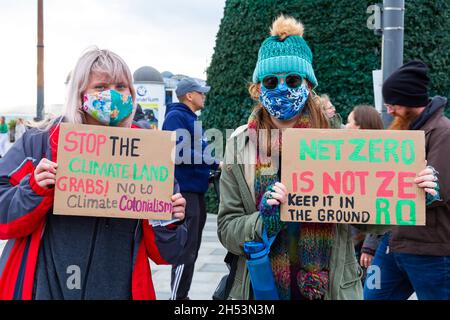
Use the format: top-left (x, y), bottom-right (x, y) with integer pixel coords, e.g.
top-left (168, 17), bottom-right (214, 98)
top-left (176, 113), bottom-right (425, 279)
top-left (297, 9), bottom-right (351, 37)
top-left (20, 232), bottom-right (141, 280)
top-left (0, 16), bottom-right (450, 300)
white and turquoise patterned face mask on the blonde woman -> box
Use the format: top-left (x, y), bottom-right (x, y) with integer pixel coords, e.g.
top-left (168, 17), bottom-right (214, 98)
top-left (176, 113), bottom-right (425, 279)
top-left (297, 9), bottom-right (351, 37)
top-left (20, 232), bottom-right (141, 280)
top-left (83, 90), bottom-right (133, 126)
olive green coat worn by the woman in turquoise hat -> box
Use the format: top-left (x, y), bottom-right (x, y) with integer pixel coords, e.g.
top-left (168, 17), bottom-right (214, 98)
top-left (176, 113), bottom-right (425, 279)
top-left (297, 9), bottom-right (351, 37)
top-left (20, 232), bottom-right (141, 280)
top-left (217, 125), bottom-right (386, 300)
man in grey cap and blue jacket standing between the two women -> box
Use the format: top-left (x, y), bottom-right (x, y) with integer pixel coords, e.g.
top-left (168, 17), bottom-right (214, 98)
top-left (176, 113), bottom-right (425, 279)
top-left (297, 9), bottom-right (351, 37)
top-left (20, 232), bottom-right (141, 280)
top-left (162, 78), bottom-right (219, 300)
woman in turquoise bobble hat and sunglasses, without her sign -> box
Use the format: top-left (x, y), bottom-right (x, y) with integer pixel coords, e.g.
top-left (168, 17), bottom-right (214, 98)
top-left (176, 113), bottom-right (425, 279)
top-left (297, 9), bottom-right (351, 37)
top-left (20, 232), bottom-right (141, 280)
top-left (217, 16), bottom-right (431, 300)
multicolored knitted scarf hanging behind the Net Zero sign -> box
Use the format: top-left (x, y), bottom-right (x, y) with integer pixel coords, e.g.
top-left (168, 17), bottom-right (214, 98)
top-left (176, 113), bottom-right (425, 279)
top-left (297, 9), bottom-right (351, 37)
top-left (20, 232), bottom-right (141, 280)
top-left (248, 111), bottom-right (335, 300)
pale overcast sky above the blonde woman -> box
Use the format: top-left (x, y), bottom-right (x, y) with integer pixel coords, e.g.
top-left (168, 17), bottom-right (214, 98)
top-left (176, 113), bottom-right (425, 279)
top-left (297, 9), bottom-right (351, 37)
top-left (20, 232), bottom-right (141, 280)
top-left (0, 0), bottom-right (225, 114)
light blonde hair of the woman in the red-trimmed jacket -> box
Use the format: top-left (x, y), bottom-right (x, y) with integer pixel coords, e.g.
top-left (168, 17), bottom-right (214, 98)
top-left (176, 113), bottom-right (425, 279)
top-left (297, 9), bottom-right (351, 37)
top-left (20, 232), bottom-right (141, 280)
top-left (32, 47), bottom-right (136, 130)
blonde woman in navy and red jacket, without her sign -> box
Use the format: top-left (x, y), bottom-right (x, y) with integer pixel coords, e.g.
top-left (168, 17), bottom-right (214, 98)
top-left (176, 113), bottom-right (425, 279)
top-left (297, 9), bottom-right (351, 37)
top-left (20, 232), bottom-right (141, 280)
top-left (0, 49), bottom-right (186, 300)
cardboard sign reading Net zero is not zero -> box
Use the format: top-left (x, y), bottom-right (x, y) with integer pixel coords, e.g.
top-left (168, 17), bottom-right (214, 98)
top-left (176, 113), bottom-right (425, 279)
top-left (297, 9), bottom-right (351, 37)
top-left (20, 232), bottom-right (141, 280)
top-left (281, 129), bottom-right (425, 226)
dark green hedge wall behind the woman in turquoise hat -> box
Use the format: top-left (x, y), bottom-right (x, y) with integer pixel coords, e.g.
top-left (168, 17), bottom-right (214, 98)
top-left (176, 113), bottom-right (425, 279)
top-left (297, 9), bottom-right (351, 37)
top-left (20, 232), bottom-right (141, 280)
top-left (202, 0), bottom-right (450, 212)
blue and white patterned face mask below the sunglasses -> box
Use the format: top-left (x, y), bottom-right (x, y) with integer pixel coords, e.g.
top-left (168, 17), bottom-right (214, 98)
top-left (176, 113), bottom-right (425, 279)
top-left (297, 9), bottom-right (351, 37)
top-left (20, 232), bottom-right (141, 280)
top-left (259, 83), bottom-right (309, 120)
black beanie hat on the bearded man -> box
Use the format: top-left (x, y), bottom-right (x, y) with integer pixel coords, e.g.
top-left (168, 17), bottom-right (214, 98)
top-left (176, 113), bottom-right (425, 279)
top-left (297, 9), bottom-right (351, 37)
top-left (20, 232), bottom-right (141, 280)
top-left (383, 60), bottom-right (430, 108)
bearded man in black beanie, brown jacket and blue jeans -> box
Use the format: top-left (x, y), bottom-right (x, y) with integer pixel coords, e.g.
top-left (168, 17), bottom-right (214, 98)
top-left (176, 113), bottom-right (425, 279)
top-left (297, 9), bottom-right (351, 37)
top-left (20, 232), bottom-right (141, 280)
top-left (364, 61), bottom-right (450, 300)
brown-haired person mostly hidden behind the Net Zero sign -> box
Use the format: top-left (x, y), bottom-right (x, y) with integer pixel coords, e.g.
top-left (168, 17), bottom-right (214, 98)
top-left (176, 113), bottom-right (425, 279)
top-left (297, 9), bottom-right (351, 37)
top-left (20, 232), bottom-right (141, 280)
top-left (345, 105), bottom-right (384, 272)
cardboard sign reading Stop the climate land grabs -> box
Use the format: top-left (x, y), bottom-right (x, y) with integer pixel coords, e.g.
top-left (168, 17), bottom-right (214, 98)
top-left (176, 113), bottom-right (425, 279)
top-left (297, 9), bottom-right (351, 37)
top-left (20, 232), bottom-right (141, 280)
top-left (54, 123), bottom-right (175, 220)
